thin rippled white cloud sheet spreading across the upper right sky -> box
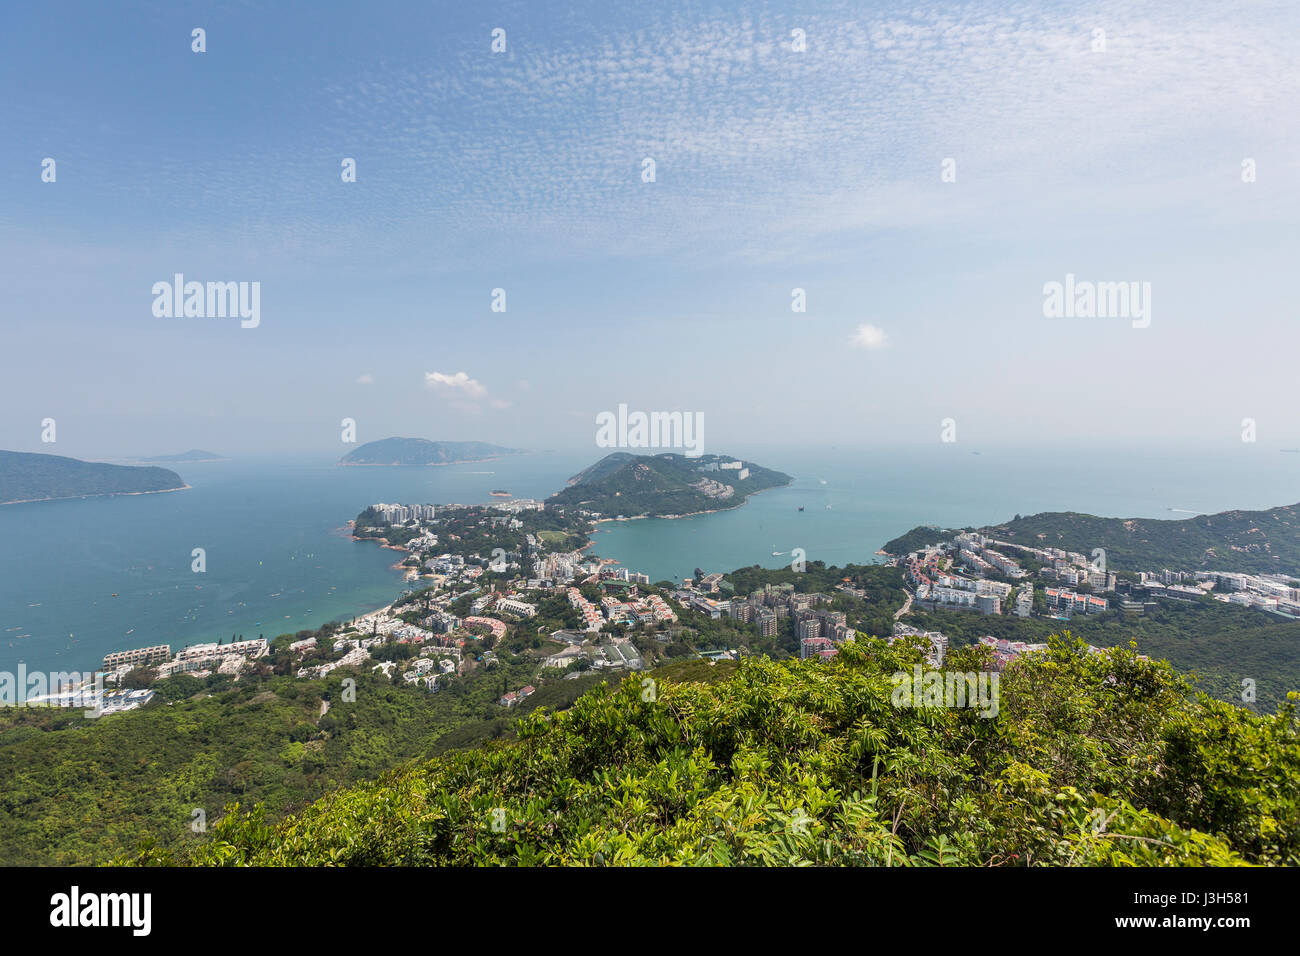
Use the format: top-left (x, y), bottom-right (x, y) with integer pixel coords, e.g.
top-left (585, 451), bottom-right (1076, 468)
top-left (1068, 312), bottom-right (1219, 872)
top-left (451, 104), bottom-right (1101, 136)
top-left (295, 0), bottom-right (1300, 261)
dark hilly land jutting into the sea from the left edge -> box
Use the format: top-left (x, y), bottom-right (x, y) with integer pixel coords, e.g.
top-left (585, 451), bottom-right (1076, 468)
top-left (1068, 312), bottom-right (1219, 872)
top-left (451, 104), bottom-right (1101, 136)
top-left (0, 451), bottom-right (189, 505)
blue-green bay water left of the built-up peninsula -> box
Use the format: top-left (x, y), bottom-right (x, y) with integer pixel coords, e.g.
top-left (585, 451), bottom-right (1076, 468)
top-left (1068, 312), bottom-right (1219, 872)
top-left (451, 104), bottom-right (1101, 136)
top-left (0, 454), bottom-right (589, 671)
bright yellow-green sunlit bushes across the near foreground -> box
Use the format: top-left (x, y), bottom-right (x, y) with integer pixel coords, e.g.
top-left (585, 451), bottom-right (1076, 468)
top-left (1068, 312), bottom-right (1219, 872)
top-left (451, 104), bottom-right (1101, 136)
top-left (135, 639), bottom-right (1300, 866)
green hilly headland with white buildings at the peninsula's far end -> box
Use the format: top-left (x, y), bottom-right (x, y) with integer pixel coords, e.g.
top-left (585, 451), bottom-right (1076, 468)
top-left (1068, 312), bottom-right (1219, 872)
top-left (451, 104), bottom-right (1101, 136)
top-left (546, 451), bottom-right (792, 518)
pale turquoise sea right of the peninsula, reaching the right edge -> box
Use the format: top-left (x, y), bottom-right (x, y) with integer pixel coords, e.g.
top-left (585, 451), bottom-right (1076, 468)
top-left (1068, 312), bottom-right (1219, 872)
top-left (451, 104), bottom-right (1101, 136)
top-left (594, 442), bottom-right (1300, 581)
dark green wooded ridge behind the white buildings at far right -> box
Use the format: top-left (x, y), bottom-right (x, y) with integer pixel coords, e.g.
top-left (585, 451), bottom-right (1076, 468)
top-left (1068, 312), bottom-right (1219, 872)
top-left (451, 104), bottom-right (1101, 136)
top-left (881, 505), bottom-right (1300, 574)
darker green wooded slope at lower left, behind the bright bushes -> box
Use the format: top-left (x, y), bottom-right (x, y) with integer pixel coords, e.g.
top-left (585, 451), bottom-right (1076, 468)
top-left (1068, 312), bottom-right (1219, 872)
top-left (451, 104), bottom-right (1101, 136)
top-left (0, 662), bottom-right (599, 866)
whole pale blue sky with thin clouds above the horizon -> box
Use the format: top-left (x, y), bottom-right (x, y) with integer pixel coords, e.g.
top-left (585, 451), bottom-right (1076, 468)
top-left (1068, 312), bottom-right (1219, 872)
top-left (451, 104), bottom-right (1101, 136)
top-left (0, 3), bottom-right (1300, 457)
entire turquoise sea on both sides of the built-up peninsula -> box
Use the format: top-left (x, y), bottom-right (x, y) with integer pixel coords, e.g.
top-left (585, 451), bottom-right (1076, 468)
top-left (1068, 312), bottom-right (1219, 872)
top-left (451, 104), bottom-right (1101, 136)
top-left (0, 442), bottom-right (1300, 671)
